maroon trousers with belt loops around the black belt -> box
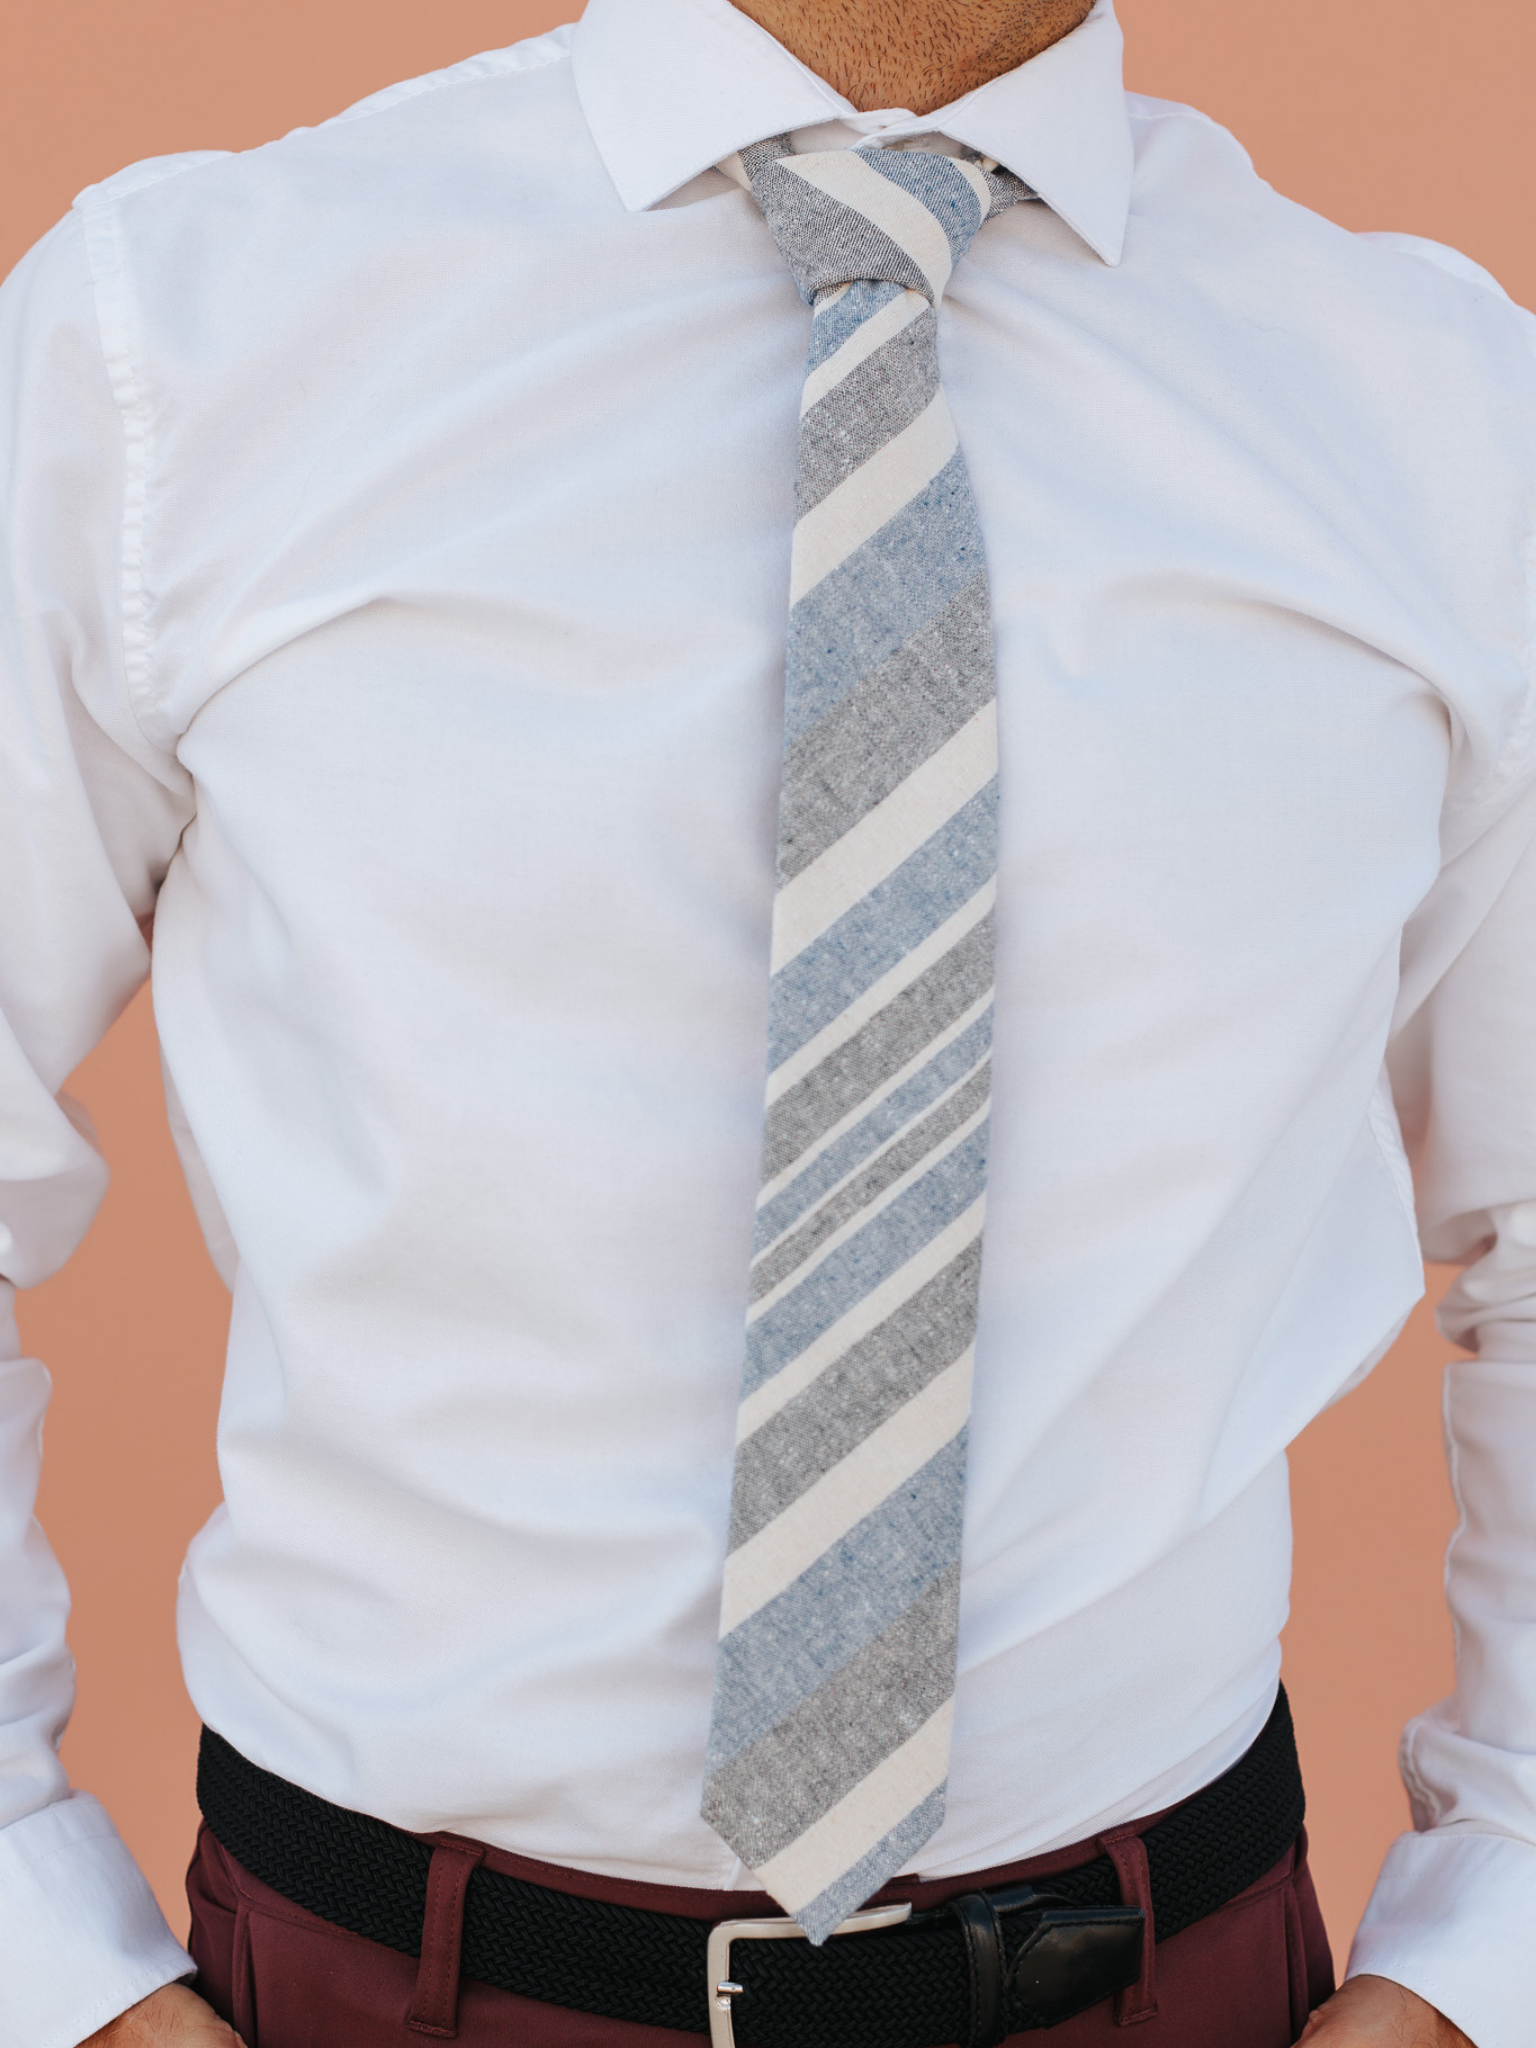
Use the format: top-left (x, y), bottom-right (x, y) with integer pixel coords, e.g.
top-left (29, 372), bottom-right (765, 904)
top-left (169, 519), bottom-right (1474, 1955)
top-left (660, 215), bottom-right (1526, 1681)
top-left (186, 1815), bottom-right (1333, 2048)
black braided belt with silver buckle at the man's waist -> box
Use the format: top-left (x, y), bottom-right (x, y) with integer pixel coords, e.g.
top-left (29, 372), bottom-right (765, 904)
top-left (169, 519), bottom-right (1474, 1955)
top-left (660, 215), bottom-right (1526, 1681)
top-left (197, 1692), bottom-right (1305, 2048)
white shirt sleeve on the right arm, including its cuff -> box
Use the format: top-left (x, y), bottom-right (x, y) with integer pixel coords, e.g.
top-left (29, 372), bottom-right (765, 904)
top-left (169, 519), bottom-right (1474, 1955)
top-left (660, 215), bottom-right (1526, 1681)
top-left (1350, 757), bottom-right (1536, 2048)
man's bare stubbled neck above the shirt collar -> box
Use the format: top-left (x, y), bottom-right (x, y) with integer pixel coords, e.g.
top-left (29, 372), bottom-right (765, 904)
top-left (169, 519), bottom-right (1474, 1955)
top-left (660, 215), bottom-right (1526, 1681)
top-left (735, 0), bottom-right (1094, 115)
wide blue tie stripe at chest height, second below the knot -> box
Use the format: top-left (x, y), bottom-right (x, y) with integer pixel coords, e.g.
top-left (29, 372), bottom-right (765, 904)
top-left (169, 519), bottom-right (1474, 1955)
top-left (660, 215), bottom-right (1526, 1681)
top-left (784, 449), bottom-right (987, 748)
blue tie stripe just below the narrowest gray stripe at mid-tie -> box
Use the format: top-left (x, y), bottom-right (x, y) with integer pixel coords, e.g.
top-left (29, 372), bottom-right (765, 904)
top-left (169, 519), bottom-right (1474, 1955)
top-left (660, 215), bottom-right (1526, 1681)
top-left (741, 1122), bottom-right (987, 1399)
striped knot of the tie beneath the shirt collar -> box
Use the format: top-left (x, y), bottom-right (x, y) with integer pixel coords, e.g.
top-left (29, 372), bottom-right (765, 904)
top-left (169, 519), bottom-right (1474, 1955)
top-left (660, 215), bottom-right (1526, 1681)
top-left (741, 135), bottom-right (1034, 305)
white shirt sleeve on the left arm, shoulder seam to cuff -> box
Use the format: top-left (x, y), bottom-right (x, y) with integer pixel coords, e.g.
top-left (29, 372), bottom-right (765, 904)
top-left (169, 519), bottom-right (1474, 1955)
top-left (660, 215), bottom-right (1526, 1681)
top-left (0, 203), bottom-right (190, 2048)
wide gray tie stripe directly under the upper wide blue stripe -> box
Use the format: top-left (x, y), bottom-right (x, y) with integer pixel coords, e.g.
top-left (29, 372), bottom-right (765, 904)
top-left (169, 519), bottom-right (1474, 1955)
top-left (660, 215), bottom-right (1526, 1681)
top-left (778, 575), bottom-right (995, 883)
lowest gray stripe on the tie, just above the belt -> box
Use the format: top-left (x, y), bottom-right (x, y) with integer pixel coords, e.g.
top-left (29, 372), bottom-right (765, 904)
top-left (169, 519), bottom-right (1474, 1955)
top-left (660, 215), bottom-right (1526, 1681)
top-left (705, 1565), bottom-right (961, 1870)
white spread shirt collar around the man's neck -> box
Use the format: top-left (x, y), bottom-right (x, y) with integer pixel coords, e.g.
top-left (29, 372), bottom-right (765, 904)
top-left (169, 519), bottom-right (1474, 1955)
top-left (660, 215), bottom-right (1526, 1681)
top-left (571, 0), bottom-right (1133, 264)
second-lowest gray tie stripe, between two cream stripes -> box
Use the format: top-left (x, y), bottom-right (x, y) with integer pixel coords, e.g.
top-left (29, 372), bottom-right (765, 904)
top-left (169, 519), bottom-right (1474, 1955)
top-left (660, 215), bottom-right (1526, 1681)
top-left (727, 1241), bottom-right (981, 1550)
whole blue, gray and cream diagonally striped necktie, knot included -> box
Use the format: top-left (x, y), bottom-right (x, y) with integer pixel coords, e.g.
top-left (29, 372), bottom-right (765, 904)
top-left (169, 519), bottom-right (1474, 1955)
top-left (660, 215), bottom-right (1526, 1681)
top-left (702, 137), bottom-right (1032, 1942)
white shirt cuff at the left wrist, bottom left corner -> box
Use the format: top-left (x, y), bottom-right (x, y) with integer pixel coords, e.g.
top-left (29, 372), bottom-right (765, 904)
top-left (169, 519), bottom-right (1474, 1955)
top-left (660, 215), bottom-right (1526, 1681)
top-left (0, 1792), bottom-right (193, 2048)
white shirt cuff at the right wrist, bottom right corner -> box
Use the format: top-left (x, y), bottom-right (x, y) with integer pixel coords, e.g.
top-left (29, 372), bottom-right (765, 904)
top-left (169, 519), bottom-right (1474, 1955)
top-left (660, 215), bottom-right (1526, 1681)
top-left (1346, 1827), bottom-right (1536, 2048)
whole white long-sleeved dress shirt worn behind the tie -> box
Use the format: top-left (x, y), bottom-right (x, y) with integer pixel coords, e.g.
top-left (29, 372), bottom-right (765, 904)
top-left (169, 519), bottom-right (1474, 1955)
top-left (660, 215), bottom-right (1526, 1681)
top-left (0, 0), bottom-right (1536, 2048)
